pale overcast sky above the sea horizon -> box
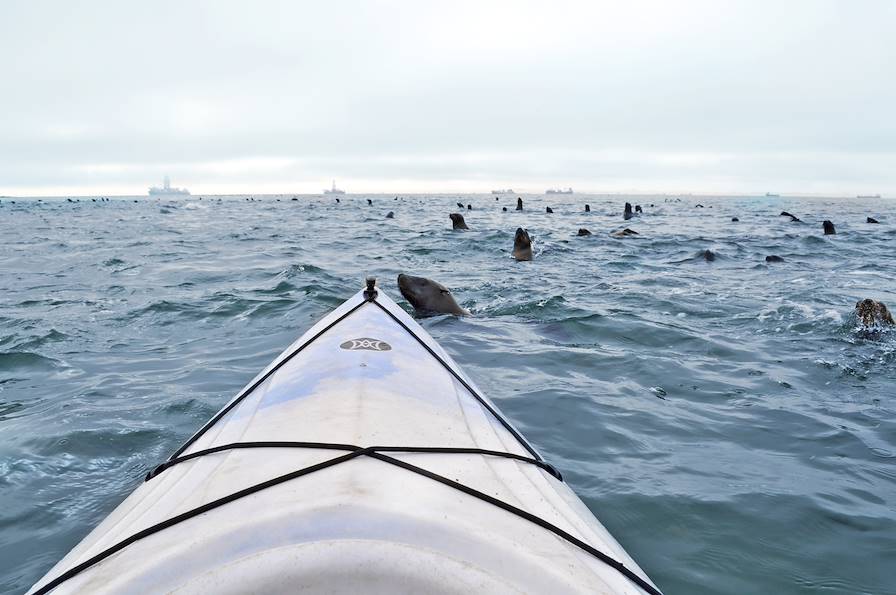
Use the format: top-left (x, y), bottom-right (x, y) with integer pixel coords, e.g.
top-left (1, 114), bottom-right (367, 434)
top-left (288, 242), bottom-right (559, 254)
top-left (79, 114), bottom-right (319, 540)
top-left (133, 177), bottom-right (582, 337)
top-left (0, 0), bottom-right (896, 196)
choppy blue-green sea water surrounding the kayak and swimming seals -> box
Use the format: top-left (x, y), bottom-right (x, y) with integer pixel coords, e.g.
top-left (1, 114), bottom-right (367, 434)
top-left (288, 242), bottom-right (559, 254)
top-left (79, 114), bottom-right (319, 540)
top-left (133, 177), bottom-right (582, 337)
top-left (0, 195), bottom-right (896, 594)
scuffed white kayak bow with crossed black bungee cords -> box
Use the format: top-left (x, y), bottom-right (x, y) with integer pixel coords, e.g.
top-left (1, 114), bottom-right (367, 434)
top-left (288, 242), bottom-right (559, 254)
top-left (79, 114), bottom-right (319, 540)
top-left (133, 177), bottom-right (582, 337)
top-left (29, 279), bottom-right (659, 595)
